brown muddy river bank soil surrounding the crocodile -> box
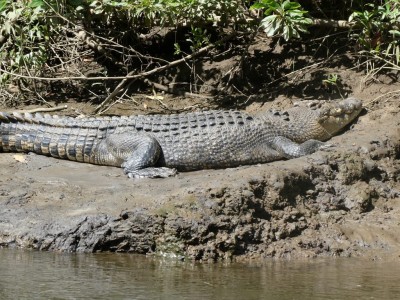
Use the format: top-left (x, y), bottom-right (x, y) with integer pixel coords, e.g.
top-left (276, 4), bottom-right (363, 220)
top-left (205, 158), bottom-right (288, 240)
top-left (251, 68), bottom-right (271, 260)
top-left (0, 34), bottom-right (400, 261)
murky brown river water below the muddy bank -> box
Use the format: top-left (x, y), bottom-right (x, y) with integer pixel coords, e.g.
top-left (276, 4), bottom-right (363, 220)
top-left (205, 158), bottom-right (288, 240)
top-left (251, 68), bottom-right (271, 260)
top-left (0, 249), bottom-right (400, 300)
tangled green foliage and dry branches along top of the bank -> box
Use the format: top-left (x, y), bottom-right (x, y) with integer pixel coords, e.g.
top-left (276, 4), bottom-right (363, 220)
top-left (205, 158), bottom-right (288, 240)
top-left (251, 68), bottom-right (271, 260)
top-left (0, 0), bottom-right (400, 110)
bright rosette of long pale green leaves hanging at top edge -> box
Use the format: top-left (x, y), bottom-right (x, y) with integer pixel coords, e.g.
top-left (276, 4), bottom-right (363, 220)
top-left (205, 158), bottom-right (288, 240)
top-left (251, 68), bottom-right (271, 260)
top-left (251, 0), bottom-right (312, 41)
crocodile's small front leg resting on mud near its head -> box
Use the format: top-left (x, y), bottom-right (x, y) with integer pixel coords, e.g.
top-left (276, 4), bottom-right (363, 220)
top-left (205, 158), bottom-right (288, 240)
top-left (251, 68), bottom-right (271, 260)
top-left (271, 136), bottom-right (330, 159)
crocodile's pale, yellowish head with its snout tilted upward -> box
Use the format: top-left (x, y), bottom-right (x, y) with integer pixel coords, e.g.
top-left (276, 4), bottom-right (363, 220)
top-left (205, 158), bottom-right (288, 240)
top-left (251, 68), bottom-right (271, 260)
top-left (318, 98), bottom-right (362, 138)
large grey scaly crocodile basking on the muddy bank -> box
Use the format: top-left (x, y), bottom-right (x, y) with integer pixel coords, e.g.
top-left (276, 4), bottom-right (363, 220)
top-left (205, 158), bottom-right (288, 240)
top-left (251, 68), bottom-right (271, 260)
top-left (0, 97), bottom-right (362, 178)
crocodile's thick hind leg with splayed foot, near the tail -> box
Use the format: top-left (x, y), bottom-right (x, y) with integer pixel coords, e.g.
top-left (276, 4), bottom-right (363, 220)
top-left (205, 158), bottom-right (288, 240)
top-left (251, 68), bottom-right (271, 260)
top-left (94, 131), bottom-right (176, 178)
